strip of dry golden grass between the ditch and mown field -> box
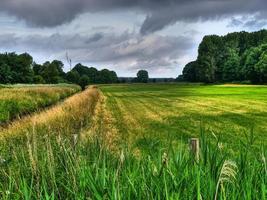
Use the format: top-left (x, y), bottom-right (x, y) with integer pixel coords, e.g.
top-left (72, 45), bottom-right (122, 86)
top-left (0, 87), bottom-right (99, 140)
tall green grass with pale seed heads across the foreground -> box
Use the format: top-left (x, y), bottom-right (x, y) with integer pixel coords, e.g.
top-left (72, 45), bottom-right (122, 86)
top-left (0, 129), bottom-right (267, 199)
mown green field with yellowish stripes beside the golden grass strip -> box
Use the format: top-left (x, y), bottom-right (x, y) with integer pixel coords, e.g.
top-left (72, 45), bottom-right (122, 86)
top-left (100, 84), bottom-right (267, 150)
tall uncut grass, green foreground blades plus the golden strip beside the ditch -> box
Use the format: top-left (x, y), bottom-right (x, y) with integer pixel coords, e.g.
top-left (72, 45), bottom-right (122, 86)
top-left (0, 88), bottom-right (267, 199)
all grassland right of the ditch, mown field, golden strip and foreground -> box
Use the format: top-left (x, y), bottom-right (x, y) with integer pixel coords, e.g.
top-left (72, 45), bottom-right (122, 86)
top-left (0, 84), bottom-right (267, 200)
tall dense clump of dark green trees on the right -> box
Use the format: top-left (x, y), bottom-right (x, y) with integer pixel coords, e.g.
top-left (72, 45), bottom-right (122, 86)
top-left (182, 30), bottom-right (267, 84)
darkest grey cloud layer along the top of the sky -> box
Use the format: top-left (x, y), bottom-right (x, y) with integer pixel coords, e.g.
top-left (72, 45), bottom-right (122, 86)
top-left (0, 0), bottom-right (267, 34)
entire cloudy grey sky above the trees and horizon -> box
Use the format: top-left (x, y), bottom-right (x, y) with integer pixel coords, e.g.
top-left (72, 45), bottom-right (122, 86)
top-left (0, 0), bottom-right (267, 78)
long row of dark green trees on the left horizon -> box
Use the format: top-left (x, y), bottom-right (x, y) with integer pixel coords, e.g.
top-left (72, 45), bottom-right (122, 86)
top-left (0, 53), bottom-right (118, 87)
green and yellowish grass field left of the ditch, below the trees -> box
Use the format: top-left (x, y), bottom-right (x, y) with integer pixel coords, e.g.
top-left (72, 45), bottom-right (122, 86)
top-left (0, 84), bottom-right (80, 124)
